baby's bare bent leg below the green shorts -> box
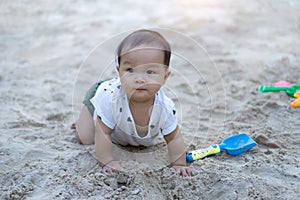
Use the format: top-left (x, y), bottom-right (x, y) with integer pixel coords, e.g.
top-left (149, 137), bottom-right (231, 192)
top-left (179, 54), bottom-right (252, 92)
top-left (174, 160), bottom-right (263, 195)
top-left (76, 105), bottom-right (95, 144)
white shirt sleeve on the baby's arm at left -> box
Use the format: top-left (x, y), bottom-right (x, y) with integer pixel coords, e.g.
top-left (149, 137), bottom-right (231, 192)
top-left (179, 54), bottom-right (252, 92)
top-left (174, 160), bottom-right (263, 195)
top-left (90, 83), bottom-right (116, 129)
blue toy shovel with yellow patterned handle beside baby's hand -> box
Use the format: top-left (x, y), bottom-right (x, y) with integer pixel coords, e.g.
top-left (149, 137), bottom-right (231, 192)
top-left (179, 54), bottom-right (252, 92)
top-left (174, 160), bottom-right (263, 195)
top-left (186, 133), bottom-right (256, 162)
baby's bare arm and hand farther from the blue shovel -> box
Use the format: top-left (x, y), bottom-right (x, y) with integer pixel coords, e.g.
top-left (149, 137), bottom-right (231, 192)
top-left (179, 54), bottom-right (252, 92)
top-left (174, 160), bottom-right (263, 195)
top-left (95, 118), bottom-right (120, 173)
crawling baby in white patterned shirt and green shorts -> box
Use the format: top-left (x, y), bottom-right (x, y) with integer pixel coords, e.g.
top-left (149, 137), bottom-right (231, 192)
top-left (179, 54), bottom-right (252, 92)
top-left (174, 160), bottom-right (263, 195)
top-left (72, 30), bottom-right (191, 176)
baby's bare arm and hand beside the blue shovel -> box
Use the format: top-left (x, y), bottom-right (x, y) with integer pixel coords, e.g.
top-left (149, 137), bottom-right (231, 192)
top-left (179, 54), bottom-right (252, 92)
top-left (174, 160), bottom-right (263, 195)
top-left (164, 127), bottom-right (192, 176)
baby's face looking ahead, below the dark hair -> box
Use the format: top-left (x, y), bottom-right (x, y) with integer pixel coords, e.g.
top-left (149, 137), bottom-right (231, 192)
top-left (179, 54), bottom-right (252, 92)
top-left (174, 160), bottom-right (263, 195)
top-left (117, 47), bottom-right (170, 102)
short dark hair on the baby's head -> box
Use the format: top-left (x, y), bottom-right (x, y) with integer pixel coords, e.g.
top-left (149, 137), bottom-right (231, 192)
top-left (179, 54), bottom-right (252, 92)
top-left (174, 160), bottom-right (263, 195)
top-left (116, 29), bottom-right (171, 66)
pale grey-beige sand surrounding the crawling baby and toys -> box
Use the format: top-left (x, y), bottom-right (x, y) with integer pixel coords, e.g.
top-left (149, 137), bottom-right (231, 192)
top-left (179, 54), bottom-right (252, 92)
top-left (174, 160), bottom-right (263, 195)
top-left (0, 0), bottom-right (300, 199)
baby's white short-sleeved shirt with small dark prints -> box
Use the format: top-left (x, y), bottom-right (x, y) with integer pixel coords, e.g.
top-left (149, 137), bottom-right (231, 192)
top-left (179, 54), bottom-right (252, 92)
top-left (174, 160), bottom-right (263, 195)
top-left (91, 77), bottom-right (178, 146)
